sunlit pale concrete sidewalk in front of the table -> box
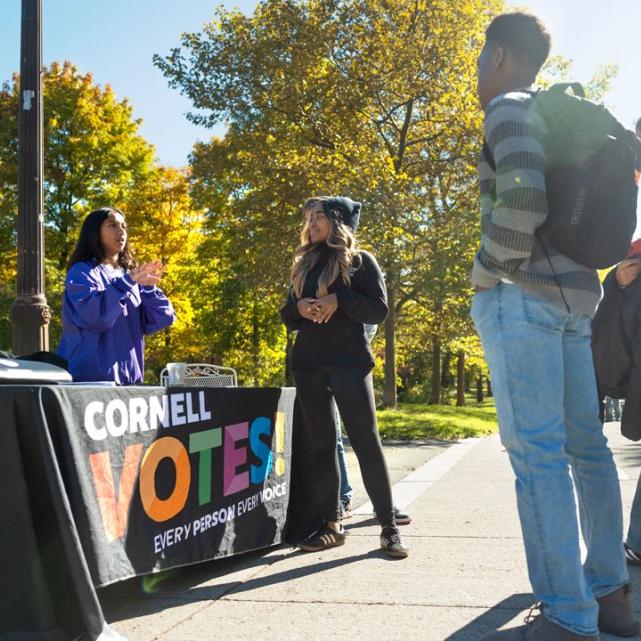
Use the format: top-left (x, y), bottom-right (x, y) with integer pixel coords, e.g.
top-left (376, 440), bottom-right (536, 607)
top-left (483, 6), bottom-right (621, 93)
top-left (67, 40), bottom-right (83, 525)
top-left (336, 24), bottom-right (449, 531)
top-left (100, 424), bottom-right (641, 641)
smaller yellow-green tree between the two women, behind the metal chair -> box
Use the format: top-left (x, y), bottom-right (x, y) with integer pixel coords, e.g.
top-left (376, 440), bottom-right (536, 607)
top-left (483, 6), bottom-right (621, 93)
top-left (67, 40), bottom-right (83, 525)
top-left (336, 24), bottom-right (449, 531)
top-left (186, 136), bottom-right (300, 385)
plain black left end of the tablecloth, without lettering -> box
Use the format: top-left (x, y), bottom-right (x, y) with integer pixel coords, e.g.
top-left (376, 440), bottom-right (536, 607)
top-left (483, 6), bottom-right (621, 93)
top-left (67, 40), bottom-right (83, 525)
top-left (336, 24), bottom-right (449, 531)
top-left (0, 386), bottom-right (116, 641)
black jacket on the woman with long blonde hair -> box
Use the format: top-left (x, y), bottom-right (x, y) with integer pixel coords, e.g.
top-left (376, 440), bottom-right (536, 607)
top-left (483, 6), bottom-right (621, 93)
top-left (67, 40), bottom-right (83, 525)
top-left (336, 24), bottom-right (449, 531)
top-left (281, 243), bottom-right (387, 369)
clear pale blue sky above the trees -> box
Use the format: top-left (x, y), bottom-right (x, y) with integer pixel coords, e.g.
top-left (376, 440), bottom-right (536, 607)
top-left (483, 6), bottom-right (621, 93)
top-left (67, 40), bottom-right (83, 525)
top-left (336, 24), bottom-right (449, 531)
top-left (0, 0), bottom-right (641, 166)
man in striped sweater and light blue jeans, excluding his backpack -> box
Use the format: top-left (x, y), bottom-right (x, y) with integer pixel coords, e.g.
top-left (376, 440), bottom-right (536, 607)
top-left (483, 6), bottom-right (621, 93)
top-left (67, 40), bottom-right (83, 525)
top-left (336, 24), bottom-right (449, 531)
top-left (471, 13), bottom-right (639, 641)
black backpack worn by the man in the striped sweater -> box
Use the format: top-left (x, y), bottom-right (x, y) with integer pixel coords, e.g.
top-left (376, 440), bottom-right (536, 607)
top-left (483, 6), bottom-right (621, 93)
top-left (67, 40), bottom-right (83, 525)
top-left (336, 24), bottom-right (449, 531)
top-left (532, 83), bottom-right (641, 269)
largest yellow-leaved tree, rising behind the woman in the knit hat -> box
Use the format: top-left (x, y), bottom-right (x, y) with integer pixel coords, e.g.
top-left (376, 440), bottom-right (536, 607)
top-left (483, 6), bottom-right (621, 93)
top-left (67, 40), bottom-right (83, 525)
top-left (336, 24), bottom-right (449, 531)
top-left (155, 0), bottom-right (502, 406)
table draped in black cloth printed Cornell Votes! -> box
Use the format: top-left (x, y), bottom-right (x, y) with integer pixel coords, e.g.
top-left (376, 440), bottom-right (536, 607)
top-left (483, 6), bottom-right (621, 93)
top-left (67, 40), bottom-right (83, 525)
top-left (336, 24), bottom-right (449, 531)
top-left (0, 385), bottom-right (296, 641)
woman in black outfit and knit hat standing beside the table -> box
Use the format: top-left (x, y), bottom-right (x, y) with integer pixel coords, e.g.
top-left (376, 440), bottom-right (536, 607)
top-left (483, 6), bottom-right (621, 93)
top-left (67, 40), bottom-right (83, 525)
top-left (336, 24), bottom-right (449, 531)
top-left (281, 197), bottom-right (408, 557)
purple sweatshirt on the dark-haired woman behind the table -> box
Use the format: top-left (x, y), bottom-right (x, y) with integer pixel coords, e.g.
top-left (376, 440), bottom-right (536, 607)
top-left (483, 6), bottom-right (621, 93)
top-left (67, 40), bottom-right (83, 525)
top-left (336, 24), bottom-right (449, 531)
top-left (58, 261), bottom-right (176, 385)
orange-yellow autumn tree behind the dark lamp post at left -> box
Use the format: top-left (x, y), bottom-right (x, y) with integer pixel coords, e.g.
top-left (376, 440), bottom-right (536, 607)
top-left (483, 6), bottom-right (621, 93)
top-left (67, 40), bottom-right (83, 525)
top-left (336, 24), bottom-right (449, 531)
top-left (0, 62), bottom-right (153, 347)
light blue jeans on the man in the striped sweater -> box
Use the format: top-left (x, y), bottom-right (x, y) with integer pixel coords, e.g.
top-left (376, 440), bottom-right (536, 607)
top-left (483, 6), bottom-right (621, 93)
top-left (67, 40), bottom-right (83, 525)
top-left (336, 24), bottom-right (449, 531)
top-left (472, 283), bottom-right (628, 635)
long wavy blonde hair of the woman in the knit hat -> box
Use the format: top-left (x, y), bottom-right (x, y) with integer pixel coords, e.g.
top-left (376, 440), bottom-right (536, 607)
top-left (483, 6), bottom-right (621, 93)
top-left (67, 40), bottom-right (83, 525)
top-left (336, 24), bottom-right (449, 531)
top-left (290, 196), bottom-right (361, 298)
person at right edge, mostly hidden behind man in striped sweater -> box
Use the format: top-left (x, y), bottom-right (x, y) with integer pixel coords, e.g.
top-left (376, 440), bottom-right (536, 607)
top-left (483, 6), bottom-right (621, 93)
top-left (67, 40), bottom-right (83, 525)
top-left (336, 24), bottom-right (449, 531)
top-left (592, 118), bottom-right (641, 566)
